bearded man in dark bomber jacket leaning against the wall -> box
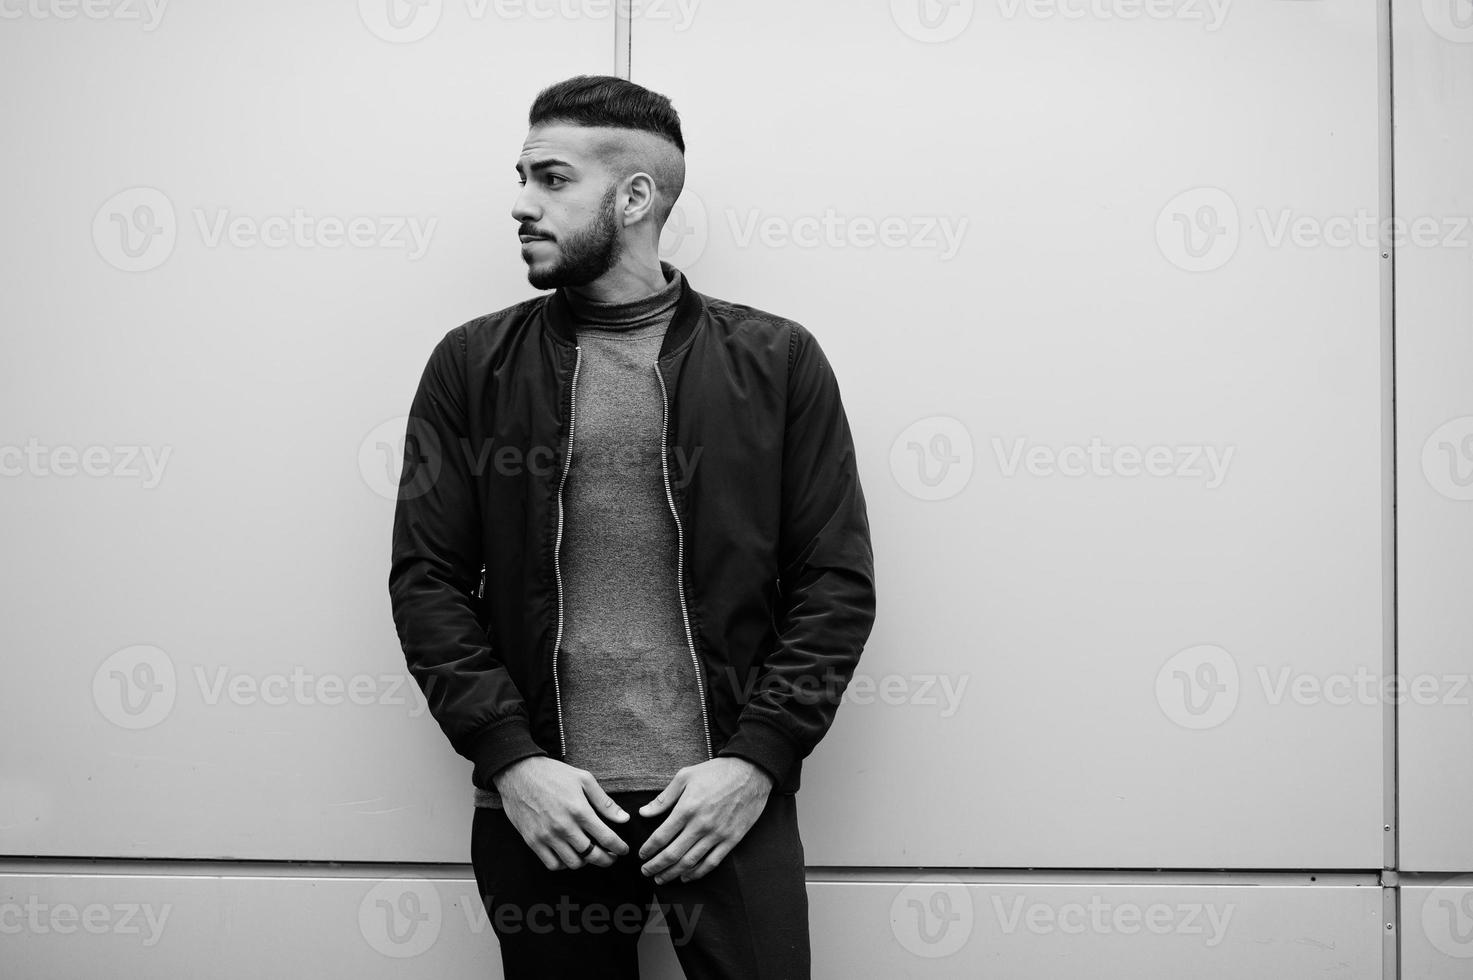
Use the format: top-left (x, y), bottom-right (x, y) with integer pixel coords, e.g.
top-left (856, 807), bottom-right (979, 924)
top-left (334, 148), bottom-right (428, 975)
top-left (389, 75), bottom-right (875, 980)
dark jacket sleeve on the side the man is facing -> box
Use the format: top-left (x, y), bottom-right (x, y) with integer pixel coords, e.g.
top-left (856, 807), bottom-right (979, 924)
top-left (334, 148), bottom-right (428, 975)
top-left (389, 326), bottom-right (546, 788)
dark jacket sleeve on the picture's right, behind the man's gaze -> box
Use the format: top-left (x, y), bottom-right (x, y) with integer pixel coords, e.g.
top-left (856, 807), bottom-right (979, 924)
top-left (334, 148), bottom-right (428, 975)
top-left (717, 324), bottom-right (875, 784)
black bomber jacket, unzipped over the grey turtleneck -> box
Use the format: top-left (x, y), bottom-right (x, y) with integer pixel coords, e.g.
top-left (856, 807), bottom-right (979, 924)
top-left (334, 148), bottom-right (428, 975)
top-left (389, 268), bottom-right (875, 793)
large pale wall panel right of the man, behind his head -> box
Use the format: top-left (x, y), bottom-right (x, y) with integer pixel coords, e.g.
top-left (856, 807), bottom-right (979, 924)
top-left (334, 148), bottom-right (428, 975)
top-left (630, 0), bottom-right (1386, 868)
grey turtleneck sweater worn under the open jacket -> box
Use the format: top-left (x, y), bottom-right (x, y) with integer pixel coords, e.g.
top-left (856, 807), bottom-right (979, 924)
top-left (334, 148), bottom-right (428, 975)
top-left (476, 262), bottom-right (707, 806)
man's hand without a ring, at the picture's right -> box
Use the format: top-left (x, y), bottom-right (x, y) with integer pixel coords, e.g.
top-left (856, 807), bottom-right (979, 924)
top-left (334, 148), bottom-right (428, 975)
top-left (639, 756), bottom-right (772, 884)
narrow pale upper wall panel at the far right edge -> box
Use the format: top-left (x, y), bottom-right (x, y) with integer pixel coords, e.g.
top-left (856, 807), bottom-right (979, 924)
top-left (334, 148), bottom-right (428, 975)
top-left (1392, 3), bottom-right (1473, 871)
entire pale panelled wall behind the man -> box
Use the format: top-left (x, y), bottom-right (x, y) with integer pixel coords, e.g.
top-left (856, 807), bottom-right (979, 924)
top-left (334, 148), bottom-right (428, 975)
top-left (0, 0), bottom-right (1473, 979)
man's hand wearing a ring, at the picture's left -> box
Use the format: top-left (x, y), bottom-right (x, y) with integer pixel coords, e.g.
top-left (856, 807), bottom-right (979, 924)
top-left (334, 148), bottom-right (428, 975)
top-left (491, 756), bottom-right (629, 871)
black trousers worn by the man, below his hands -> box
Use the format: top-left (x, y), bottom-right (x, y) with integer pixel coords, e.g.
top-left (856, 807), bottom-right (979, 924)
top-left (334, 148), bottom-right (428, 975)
top-left (471, 790), bottom-right (810, 980)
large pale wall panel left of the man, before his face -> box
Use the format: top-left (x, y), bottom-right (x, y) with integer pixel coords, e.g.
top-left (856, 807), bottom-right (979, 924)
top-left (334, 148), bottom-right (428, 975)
top-left (0, 0), bottom-right (614, 861)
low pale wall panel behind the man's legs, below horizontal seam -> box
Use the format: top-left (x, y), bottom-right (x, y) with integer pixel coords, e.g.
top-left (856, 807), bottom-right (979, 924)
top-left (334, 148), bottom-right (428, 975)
top-left (0, 871), bottom-right (1384, 980)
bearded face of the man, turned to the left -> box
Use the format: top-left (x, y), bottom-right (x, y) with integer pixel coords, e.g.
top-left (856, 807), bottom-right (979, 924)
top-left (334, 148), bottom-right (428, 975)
top-left (511, 124), bottom-right (623, 289)
